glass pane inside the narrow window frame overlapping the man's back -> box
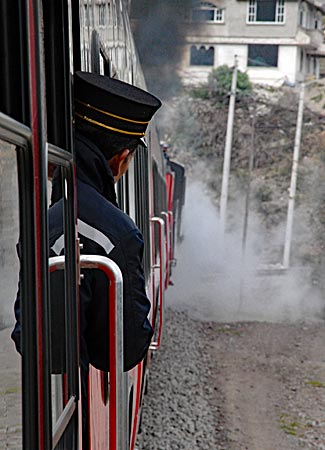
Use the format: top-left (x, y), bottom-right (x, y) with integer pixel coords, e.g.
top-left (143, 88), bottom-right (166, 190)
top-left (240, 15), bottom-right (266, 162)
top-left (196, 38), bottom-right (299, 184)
top-left (48, 159), bottom-right (76, 448)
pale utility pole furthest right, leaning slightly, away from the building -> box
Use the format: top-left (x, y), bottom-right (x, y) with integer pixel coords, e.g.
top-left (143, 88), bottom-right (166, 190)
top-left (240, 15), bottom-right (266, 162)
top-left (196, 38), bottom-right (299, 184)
top-left (283, 83), bottom-right (305, 269)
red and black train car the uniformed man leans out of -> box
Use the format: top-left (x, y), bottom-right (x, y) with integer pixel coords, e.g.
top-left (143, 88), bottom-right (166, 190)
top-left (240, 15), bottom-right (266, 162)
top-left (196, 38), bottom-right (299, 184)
top-left (0, 0), bottom-right (185, 450)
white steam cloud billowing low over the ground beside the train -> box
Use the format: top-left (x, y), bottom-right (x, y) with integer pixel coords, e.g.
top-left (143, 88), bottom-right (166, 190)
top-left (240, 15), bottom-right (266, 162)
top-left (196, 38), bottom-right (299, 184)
top-left (167, 182), bottom-right (323, 322)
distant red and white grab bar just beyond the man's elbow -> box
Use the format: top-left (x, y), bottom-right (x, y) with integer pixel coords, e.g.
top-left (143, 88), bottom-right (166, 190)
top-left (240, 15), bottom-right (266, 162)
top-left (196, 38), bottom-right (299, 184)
top-left (149, 217), bottom-right (166, 350)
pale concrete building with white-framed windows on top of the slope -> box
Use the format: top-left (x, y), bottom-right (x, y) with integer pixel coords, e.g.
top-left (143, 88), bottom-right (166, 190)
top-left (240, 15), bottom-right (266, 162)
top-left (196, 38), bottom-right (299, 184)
top-left (179, 0), bottom-right (325, 85)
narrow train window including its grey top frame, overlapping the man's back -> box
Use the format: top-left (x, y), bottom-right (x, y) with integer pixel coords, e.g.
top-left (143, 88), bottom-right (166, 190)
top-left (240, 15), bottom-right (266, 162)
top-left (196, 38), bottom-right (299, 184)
top-left (48, 150), bottom-right (78, 448)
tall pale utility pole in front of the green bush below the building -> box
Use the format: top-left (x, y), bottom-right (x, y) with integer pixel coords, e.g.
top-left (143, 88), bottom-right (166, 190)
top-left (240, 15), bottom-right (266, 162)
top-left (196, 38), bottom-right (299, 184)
top-left (220, 55), bottom-right (238, 239)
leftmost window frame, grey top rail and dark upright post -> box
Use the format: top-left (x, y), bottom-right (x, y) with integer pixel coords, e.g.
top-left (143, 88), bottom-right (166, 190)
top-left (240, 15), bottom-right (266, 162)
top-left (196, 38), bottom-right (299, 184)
top-left (0, 113), bottom-right (44, 446)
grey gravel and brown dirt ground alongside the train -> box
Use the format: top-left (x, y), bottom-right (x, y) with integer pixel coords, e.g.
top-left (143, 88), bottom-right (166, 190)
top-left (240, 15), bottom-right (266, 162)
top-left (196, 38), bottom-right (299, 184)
top-left (138, 309), bottom-right (325, 450)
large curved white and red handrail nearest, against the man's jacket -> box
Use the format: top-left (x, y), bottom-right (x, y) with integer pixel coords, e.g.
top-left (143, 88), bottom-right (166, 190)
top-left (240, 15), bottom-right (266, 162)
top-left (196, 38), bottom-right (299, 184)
top-left (50, 255), bottom-right (129, 450)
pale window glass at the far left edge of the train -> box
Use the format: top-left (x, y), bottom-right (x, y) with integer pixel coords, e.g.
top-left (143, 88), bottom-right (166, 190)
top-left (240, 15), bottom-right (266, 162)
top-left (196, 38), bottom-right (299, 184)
top-left (0, 140), bottom-right (22, 448)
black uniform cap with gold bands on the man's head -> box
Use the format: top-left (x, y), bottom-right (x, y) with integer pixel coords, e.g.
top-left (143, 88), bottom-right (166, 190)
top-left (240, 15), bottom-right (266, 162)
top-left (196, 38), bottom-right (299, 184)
top-left (74, 72), bottom-right (161, 140)
